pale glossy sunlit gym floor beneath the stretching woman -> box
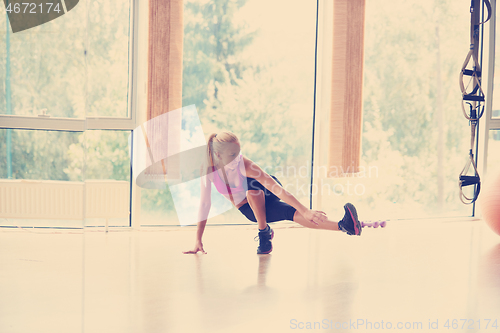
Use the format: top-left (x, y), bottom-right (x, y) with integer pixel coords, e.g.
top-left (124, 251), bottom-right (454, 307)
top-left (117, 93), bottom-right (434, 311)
top-left (0, 219), bottom-right (500, 333)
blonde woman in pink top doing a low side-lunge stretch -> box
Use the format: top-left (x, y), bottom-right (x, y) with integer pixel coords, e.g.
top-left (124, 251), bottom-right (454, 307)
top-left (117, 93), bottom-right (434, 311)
top-left (184, 132), bottom-right (361, 254)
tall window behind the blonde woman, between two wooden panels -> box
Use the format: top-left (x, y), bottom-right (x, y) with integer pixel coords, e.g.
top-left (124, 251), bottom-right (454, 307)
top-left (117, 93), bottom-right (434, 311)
top-left (137, 0), bottom-right (316, 225)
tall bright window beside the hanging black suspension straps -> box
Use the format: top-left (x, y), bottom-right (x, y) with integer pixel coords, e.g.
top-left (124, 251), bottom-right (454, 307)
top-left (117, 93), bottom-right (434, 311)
top-left (360, 0), bottom-right (471, 218)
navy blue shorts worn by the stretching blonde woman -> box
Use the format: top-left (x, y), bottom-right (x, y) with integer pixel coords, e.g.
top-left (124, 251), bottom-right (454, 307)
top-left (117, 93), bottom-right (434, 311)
top-left (239, 175), bottom-right (297, 222)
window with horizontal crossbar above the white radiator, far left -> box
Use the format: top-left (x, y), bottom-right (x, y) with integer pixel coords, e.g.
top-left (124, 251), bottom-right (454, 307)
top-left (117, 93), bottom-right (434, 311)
top-left (0, 0), bottom-right (137, 227)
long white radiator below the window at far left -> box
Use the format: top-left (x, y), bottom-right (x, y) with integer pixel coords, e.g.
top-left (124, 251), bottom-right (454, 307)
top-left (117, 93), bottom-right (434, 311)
top-left (0, 179), bottom-right (130, 220)
